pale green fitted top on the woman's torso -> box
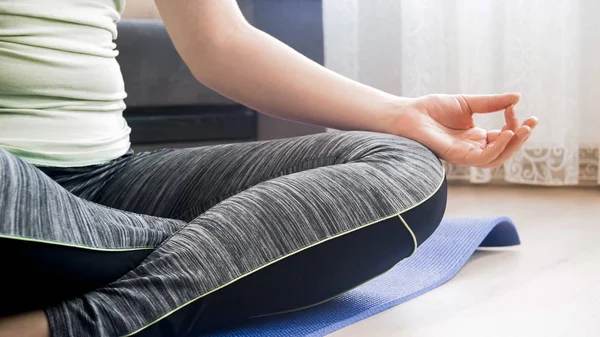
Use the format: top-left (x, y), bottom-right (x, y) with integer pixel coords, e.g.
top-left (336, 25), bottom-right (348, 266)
top-left (0, 0), bottom-right (130, 167)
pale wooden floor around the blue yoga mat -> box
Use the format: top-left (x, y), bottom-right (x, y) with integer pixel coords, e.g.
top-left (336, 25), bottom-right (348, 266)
top-left (331, 186), bottom-right (600, 337)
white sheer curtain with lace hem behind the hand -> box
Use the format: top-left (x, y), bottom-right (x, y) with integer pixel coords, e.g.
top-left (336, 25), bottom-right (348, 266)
top-left (323, 0), bottom-right (600, 185)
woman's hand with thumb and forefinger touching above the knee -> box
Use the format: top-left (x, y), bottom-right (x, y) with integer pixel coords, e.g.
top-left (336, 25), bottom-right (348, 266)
top-left (398, 94), bottom-right (538, 168)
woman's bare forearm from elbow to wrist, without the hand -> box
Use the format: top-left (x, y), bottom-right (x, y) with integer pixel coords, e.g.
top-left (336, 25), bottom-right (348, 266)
top-left (171, 26), bottom-right (404, 132)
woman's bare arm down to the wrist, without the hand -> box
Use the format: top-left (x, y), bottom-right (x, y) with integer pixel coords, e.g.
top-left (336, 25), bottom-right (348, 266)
top-left (156, 0), bottom-right (404, 133)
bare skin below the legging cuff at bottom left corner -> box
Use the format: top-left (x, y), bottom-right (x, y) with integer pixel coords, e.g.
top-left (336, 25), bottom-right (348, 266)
top-left (0, 311), bottom-right (50, 337)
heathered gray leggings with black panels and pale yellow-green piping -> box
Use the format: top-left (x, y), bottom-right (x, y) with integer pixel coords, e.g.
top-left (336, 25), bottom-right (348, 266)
top-left (0, 132), bottom-right (446, 337)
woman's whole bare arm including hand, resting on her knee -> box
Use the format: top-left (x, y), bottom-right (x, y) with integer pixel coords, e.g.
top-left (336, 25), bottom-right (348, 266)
top-left (155, 0), bottom-right (537, 167)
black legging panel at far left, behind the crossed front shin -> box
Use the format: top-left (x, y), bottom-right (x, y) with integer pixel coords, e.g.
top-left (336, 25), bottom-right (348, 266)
top-left (0, 238), bottom-right (152, 316)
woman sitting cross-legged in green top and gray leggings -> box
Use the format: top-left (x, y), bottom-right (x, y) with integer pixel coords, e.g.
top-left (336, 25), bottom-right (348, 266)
top-left (0, 0), bottom-right (537, 337)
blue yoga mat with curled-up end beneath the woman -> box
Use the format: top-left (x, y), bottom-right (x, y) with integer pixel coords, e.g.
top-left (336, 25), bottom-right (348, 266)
top-left (206, 217), bottom-right (520, 337)
